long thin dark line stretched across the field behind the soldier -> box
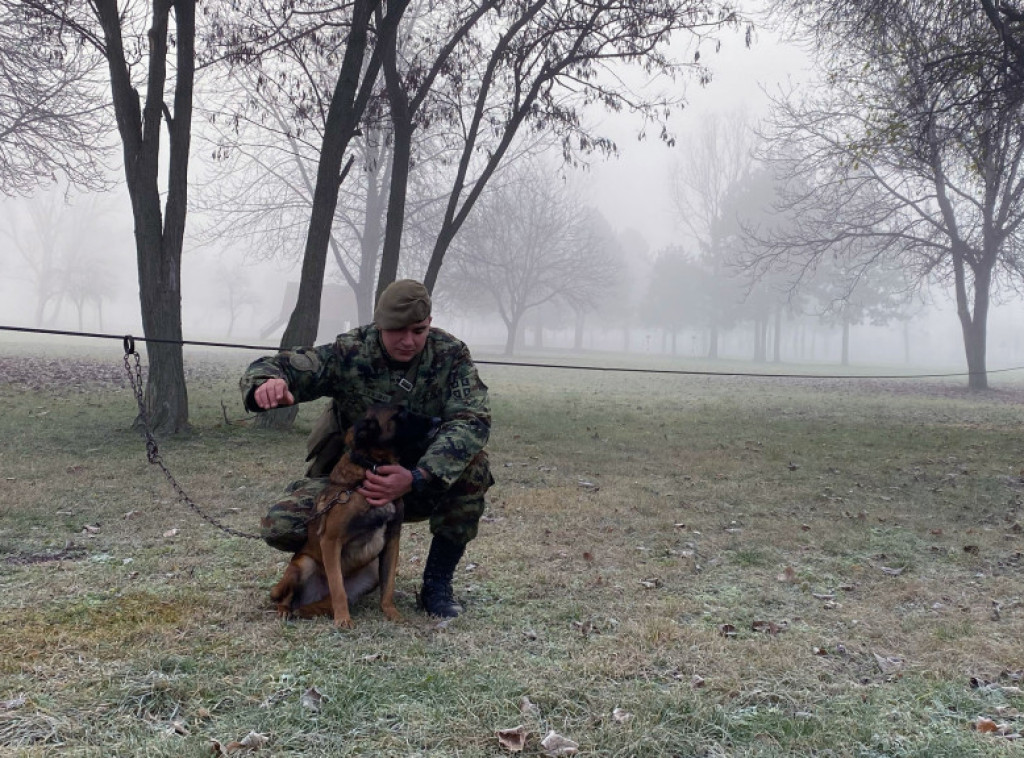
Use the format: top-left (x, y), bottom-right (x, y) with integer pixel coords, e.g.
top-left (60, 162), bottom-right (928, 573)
top-left (0, 325), bottom-right (1024, 379)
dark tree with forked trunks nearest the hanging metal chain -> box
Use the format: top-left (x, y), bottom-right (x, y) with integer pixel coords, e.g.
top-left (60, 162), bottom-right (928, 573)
top-left (15, 0), bottom-right (196, 433)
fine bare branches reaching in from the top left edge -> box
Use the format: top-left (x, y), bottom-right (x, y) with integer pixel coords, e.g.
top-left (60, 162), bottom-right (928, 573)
top-left (0, 0), bottom-right (114, 195)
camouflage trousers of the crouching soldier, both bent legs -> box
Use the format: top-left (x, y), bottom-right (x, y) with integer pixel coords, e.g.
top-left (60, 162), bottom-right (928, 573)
top-left (260, 451), bottom-right (495, 552)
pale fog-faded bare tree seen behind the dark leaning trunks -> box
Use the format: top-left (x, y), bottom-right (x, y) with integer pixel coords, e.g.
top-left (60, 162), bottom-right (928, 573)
top-left (197, 66), bottom-right (391, 323)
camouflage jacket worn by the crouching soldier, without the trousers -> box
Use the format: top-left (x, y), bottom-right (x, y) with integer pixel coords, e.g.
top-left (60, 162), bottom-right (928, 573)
top-left (240, 325), bottom-right (490, 488)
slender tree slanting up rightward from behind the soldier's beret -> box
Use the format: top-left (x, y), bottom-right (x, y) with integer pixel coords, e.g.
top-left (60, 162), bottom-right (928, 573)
top-left (415, 0), bottom-right (739, 289)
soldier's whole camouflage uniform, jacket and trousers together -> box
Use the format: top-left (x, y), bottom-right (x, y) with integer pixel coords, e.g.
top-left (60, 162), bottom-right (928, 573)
top-left (240, 325), bottom-right (494, 550)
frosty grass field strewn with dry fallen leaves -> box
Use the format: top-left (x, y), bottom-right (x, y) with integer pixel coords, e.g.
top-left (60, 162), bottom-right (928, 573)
top-left (0, 347), bottom-right (1024, 758)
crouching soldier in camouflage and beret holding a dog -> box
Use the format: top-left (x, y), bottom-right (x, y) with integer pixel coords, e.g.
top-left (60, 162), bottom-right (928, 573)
top-left (240, 280), bottom-right (494, 618)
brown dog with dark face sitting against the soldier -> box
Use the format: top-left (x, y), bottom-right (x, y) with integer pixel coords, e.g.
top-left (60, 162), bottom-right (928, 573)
top-left (270, 405), bottom-right (431, 629)
